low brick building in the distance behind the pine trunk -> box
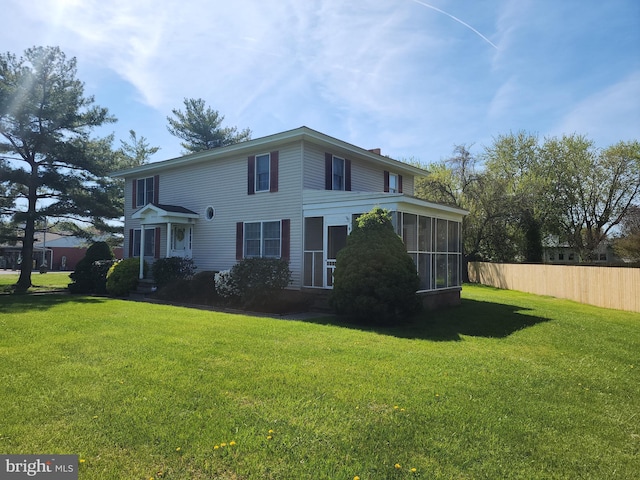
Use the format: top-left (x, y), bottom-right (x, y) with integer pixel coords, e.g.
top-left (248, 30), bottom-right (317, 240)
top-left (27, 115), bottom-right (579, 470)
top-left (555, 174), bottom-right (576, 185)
top-left (0, 232), bottom-right (123, 271)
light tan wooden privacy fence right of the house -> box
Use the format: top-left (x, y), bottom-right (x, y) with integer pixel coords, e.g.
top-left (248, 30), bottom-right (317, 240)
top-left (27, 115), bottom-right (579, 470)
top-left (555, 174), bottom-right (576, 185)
top-left (469, 262), bottom-right (640, 312)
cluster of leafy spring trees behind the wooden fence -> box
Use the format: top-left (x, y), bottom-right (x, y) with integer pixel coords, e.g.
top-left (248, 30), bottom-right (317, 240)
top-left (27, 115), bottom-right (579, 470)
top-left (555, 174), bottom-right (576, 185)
top-left (416, 132), bottom-right (640, 262)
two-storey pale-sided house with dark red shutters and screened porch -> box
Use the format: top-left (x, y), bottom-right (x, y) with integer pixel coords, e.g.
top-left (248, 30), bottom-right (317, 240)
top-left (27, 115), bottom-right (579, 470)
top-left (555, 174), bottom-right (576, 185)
top-left (112, 127), bottom-right (467, 308)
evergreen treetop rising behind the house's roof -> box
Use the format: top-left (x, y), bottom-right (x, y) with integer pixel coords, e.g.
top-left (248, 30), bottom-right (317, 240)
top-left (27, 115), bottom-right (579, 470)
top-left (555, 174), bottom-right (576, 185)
top-left (167, 98), bottom-right (251, 153)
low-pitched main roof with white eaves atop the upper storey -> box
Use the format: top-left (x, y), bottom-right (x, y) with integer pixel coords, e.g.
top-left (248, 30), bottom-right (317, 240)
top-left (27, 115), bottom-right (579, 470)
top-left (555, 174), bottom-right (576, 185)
top-left (111, 126), bottom-right (427, 178)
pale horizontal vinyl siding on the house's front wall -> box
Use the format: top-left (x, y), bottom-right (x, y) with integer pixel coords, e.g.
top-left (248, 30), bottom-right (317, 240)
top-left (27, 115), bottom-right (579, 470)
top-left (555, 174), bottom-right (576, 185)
top-left (125, 142), bottom-right (302, 287)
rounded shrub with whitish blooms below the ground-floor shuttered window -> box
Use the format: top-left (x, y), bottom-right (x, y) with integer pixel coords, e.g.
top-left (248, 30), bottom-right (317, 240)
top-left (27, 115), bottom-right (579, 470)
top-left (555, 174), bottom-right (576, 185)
top-left (216, 258), bottom-right (291, 308)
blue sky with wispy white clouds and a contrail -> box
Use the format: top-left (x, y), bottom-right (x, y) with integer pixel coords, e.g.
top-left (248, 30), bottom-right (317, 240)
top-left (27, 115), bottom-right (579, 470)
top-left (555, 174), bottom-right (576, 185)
top-left (0, 0), bottom-right (640, 164)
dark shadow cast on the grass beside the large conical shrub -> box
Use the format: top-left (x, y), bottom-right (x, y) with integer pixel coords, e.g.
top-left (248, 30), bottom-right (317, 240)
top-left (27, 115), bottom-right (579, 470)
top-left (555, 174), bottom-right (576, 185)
top-left (304, 299), bottom-right (549, 342)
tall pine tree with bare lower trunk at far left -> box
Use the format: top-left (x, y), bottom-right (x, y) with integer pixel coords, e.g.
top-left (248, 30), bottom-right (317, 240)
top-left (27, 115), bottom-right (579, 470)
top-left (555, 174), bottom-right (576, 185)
top-left (0, 47), bottom-right (117, 291)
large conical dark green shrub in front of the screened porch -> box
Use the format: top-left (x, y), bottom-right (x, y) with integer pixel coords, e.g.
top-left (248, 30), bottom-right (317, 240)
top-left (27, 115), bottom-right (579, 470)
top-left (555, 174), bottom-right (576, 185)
top-left (329, 207), bottom-right (420, 325)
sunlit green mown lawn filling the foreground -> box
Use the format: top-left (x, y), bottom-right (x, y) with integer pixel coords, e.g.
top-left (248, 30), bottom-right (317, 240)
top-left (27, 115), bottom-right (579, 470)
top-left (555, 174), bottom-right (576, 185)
top-left (0, 286), bottom-right (640, 480)
